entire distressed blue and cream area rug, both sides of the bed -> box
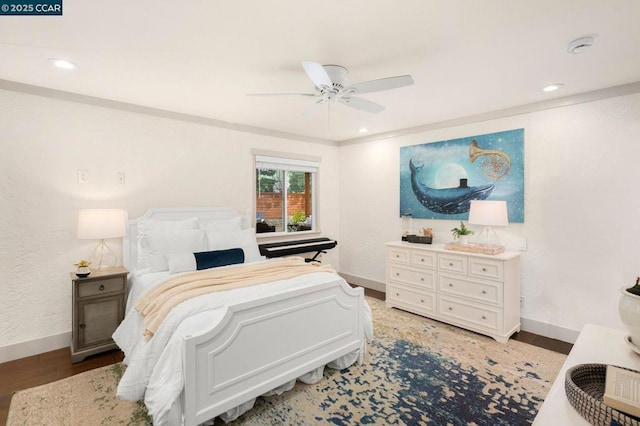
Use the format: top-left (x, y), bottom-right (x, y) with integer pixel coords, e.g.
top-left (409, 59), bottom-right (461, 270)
top-left (7, 298), bottom-right (565, 426)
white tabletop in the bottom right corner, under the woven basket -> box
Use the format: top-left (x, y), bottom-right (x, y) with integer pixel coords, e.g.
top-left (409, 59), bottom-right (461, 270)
top-left (533, 324), bottom-right (640, 426)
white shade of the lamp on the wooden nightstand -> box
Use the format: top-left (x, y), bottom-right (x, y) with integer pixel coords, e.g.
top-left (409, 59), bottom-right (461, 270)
top-left (76, 209), bottom-right (127, 240)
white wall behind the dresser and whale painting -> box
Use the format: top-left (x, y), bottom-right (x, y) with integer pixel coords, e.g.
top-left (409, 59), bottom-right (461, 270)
top-left (340, 94), bottom-right (640, 341)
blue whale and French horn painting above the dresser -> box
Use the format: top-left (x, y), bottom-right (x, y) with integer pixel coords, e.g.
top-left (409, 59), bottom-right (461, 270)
top-left (400, 129), bottom-right (524, 223)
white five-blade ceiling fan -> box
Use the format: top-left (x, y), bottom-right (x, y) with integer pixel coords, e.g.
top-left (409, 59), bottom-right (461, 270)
top-left (248, 61), bottom-right (413, 115)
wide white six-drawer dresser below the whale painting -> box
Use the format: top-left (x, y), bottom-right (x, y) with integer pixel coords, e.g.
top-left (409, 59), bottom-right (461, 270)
top-left (386, 241), bottom-right (520, 343)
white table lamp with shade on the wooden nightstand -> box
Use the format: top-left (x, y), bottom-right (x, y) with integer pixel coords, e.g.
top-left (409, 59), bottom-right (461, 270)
top-left (76, 209), bottom-right (127, 269)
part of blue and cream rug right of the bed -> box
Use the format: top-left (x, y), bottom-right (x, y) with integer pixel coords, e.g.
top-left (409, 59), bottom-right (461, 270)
top-left (224, 298), bottom-right (566, 426)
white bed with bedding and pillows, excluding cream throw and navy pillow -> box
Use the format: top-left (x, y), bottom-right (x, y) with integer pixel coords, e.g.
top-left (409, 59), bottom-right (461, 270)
top-left (113, 208), bottom-right (372, 425)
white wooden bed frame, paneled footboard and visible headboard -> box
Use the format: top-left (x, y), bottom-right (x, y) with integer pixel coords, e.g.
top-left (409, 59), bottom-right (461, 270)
top-left (123, 208), bottom-right (365, 426)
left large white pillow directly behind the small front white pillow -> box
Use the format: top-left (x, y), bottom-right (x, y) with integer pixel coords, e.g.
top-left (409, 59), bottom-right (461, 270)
top-left (138, 229), bottom-right (205, 273)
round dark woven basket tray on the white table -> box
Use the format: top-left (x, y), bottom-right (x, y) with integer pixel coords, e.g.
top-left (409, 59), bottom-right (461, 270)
top-left (564, 364), bottom-right (640, 426)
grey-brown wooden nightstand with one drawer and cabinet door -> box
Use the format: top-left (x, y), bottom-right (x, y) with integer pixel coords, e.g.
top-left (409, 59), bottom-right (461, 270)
top-left (71, 266), bottom-right (129, 362)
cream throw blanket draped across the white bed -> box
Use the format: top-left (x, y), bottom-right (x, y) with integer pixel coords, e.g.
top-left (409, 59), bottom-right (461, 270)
top-left (135, 257), bottom-right (335, 339)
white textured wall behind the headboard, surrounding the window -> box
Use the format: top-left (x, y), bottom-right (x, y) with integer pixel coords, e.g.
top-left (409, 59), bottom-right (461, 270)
top-left (0, 91), bottom-right (339, 362)
